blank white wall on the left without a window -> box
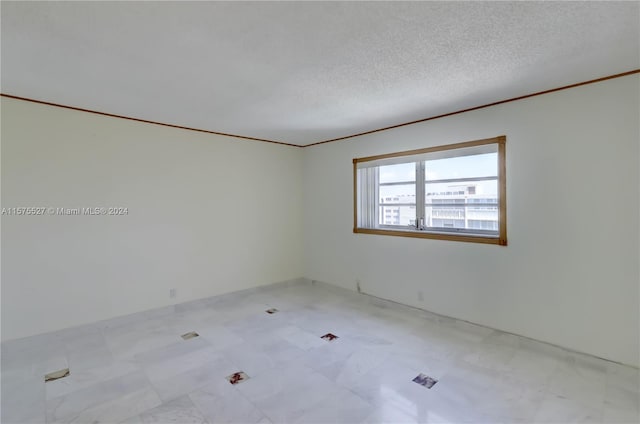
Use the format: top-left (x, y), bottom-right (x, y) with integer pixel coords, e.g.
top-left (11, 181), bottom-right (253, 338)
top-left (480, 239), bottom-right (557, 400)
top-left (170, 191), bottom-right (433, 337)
top-left (2, 98), bottom-right (303, 340)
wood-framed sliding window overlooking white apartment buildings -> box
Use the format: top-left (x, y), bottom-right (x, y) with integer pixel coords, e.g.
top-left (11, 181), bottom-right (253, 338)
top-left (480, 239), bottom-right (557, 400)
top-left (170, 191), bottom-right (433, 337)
top-left (353, 132), bottom-right (507, 246)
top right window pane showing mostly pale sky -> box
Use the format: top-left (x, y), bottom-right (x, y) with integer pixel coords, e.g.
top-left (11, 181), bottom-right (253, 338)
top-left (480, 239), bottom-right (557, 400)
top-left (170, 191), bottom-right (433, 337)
top-left (425, 153), bottom-right (498, 181)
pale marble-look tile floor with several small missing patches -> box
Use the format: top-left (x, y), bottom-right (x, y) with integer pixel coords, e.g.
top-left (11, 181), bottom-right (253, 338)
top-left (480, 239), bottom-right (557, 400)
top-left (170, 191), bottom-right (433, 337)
top-left (0, 283), bottom-right (640, 424)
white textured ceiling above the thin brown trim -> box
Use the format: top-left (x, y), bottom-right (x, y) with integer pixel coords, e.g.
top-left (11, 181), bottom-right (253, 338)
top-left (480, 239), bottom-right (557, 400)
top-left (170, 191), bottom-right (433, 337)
top-left (0, 1), bottom-right (640, 145)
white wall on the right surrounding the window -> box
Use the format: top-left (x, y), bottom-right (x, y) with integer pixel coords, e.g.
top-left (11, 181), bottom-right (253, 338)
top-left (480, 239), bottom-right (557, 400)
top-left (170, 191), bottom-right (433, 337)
top-left (304, 75), bottom-right (640, 366)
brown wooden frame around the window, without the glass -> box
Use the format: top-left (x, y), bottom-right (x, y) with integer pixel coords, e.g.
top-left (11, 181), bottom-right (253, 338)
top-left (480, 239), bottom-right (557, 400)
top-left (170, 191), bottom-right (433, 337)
top-left (353, 135), bottom-right (507, 246)
